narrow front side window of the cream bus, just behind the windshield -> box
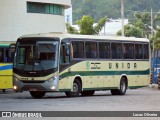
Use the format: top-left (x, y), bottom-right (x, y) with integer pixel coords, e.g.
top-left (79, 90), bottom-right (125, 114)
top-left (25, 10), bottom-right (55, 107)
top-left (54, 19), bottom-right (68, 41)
top-left (61, 43), bottom-right (70, 64)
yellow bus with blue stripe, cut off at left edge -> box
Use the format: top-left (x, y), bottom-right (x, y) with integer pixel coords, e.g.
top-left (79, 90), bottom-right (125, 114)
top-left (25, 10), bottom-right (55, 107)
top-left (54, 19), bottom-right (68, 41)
top-left (0, 42), bottom-right (15, 92)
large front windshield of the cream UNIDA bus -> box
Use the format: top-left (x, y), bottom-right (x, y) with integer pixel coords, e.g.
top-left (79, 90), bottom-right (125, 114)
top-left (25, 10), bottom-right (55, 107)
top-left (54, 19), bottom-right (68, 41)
top-left (14, 41), bottom-right (58, 71)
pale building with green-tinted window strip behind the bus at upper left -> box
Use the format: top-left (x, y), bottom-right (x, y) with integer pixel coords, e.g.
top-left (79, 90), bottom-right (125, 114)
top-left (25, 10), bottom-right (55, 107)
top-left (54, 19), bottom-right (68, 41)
top-left (0, 0), bottom-right (71, 41)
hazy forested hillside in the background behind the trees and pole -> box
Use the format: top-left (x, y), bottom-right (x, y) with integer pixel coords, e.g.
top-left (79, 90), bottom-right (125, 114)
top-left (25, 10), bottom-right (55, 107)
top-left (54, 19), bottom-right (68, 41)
top-left (72, 0), bottom-right (160, 23)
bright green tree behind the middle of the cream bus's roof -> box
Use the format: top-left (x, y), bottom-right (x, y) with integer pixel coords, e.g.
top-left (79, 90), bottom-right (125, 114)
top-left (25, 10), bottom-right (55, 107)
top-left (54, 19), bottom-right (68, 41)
top-left (66, 15), bottom-right (108, 35)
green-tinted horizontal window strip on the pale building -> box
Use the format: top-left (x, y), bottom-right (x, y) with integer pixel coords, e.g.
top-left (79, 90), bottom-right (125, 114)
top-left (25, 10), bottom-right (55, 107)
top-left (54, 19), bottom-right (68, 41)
top-left (27, 2), bottom-right (63, 15)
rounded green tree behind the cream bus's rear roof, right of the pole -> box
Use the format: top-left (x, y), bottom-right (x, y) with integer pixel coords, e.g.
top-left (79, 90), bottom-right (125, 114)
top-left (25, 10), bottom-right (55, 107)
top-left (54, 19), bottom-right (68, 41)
top-left (117, 25), bottom-right (143, 38)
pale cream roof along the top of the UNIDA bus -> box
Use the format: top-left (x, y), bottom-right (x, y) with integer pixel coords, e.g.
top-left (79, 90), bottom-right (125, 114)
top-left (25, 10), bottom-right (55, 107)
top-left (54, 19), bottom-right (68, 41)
top-left (20, 33), bottom-right (149, 42)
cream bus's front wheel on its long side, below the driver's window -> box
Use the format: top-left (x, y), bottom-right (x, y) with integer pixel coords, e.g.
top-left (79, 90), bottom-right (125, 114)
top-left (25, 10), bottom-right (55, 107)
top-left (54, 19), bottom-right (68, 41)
top-left (65, 79), bottom-right (82, 97)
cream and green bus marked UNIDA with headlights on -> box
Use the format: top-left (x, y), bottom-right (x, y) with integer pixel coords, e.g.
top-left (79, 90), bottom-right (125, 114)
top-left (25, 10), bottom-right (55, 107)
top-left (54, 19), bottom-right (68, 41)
top-left (13, 33), bottom-right (150, 98)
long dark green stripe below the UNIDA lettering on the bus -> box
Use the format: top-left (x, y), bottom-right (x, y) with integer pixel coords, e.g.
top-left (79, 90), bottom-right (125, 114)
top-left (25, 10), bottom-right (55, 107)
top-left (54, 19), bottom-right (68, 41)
top-left (60, 69), bottom-right (150, 79)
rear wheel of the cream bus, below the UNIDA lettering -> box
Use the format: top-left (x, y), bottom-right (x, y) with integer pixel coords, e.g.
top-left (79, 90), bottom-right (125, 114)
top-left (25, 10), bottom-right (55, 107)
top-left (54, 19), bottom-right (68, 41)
top-left (111, 77), bottom-right (127, 95)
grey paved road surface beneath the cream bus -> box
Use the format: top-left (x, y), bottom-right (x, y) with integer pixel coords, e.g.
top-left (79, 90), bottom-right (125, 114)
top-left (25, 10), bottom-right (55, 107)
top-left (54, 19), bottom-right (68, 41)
top-left (0, 87), bottom-right (160, 120)
